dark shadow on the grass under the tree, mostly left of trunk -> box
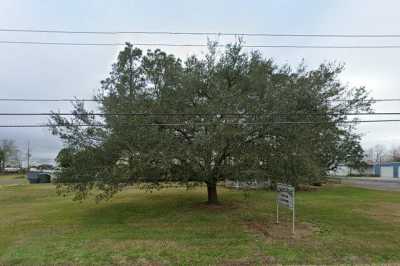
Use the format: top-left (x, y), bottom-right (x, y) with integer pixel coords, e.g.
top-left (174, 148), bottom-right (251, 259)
top-left (76, 188), bottom-right (238, 228)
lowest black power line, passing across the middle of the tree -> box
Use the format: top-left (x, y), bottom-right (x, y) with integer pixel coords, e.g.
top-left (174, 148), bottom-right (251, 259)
top-left (0, 119), bottom-right (400, 128)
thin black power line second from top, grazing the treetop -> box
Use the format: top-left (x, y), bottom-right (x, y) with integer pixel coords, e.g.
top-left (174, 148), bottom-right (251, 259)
top-left (0, 40), bottom-right (400, 49)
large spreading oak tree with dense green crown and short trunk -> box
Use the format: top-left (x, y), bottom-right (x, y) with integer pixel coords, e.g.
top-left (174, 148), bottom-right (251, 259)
top-left (51, 44), bottom-right (370, 203)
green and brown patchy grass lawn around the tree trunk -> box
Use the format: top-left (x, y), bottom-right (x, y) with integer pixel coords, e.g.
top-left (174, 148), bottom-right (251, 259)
top-left (0, 176), bottom-right (400, 265)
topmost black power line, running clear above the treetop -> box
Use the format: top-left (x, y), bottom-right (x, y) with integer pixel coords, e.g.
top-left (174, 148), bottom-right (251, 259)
top-left (0, 28), bottom-right (400, 38)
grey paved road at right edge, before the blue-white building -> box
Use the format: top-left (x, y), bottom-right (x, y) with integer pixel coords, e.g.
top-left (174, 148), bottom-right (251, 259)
top-left (341, 177), bottom-right (400, 191)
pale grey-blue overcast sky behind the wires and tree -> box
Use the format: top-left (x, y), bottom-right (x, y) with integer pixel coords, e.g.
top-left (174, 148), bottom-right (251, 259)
top-left (0, 0), bottom-right (400, 162)
